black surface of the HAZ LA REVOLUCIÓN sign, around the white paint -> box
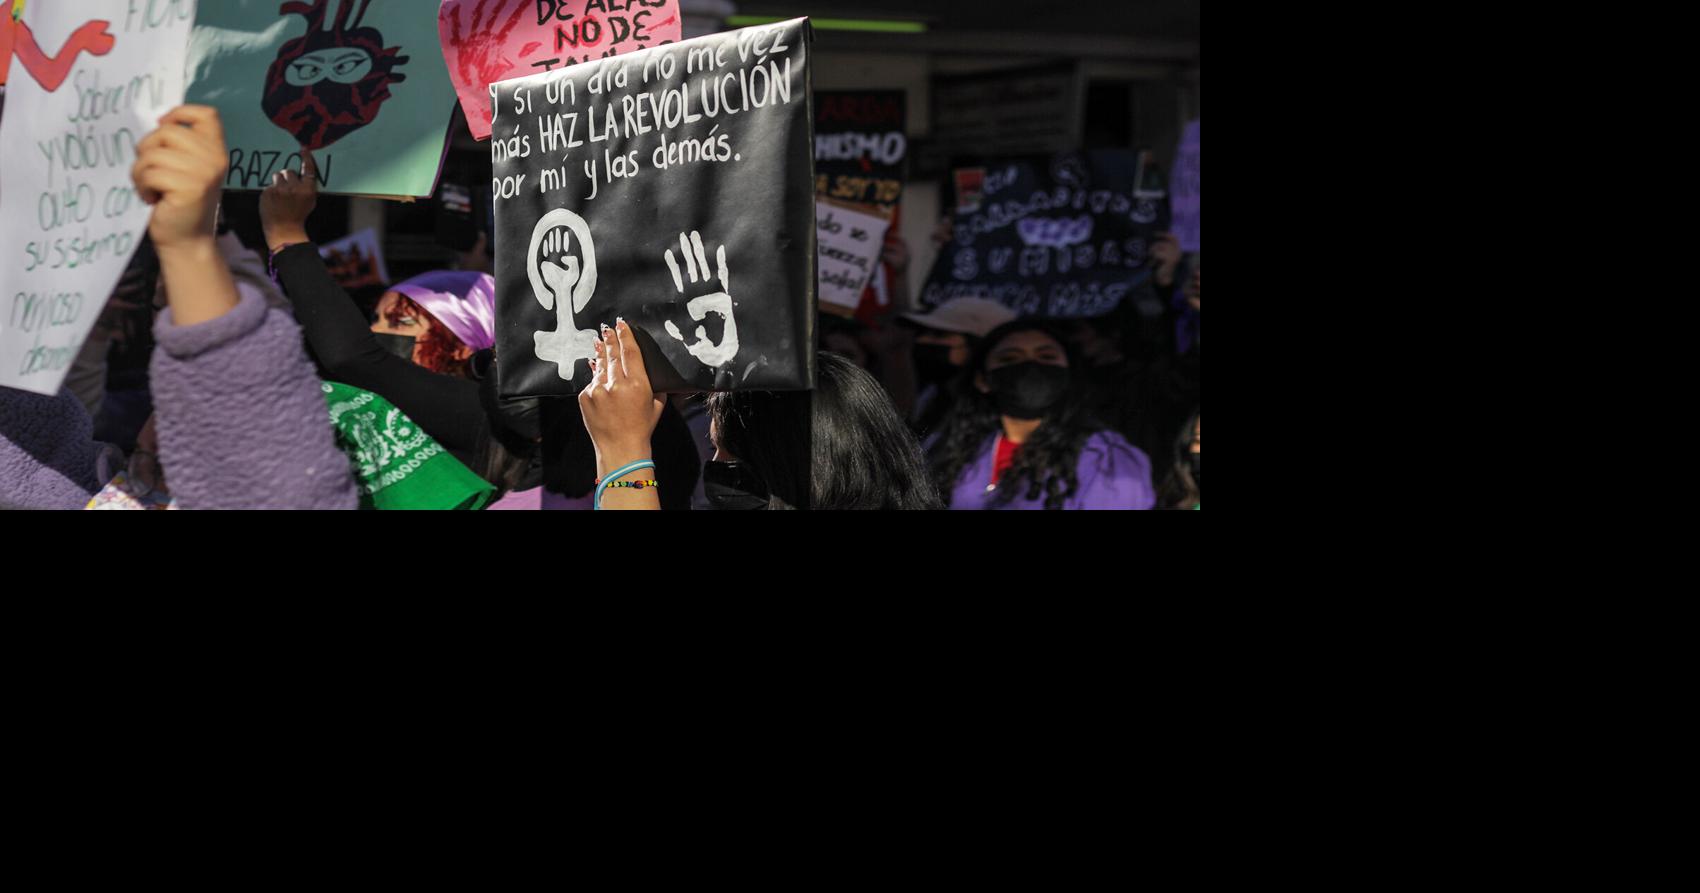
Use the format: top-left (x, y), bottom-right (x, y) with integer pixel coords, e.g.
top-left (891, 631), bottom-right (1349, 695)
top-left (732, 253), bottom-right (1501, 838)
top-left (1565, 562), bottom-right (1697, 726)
top-left (491, 20), bottom-right (818, 398)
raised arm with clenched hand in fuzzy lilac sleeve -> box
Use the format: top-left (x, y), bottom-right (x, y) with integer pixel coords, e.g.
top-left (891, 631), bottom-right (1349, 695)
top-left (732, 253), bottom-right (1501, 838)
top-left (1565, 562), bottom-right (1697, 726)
top-left (133, 105), bottom-right (359, 509)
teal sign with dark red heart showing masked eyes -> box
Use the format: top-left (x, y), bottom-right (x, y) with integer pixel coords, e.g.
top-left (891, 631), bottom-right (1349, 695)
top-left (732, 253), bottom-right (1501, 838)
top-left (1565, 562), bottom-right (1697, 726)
top-left (189, 0), bottom-right (456, 197)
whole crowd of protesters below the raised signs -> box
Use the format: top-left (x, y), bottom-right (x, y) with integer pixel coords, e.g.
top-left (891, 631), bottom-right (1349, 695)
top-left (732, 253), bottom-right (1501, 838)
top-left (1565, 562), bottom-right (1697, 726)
top-left (0, 105), bottom-right (1200, 510)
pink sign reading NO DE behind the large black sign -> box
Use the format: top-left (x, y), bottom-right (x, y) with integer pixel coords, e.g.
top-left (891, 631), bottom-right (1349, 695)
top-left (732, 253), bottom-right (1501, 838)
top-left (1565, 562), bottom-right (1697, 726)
top-left (437, 0), bottom-right (683, 139)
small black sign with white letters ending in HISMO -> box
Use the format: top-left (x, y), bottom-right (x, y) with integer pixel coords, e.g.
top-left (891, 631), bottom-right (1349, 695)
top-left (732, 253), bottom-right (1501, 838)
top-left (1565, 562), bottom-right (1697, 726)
top-left (814, 90), bottom-right (910, 208)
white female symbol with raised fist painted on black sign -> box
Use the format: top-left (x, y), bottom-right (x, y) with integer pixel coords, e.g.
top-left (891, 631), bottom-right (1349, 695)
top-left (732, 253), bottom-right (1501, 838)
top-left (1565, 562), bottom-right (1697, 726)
top-left (525, 209), bottom-right (598, 381)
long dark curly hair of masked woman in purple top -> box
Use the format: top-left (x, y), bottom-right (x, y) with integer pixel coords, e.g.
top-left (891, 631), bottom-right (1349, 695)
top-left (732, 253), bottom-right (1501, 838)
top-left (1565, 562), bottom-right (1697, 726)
top-left (932, 320), bottom-right (1105, 512)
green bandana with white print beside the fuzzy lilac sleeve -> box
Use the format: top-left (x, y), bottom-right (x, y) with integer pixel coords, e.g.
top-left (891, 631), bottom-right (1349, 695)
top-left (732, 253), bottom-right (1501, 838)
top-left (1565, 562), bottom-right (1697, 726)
top-left (325, 381), bottom-right (496, 512)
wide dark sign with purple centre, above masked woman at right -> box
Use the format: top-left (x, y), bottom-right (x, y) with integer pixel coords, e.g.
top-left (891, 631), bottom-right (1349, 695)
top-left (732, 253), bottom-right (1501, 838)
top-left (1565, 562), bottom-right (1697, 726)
top-left (921, 150), bottom-right (1168, 316)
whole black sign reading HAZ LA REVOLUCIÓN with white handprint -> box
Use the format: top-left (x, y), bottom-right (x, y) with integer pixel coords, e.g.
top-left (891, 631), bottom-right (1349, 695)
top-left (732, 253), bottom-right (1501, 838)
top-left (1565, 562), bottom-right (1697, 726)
top-left (491, 19), bottom-right (816, 396)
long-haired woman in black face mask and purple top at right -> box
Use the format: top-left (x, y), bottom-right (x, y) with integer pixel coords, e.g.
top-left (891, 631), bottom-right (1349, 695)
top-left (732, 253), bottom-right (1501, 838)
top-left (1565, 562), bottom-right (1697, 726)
top-left (932, 320), bottom-right (1156, 510)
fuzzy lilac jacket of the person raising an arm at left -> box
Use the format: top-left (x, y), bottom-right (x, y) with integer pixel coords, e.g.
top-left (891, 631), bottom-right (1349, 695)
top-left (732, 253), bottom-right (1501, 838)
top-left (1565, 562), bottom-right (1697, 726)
top-left (0, 284), bottom-right (360, 509)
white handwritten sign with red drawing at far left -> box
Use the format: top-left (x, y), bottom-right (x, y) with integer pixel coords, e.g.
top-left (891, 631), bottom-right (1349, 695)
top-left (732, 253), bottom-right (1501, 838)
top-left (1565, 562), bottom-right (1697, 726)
top-left (0, 0), bottom-right (196, 395)
